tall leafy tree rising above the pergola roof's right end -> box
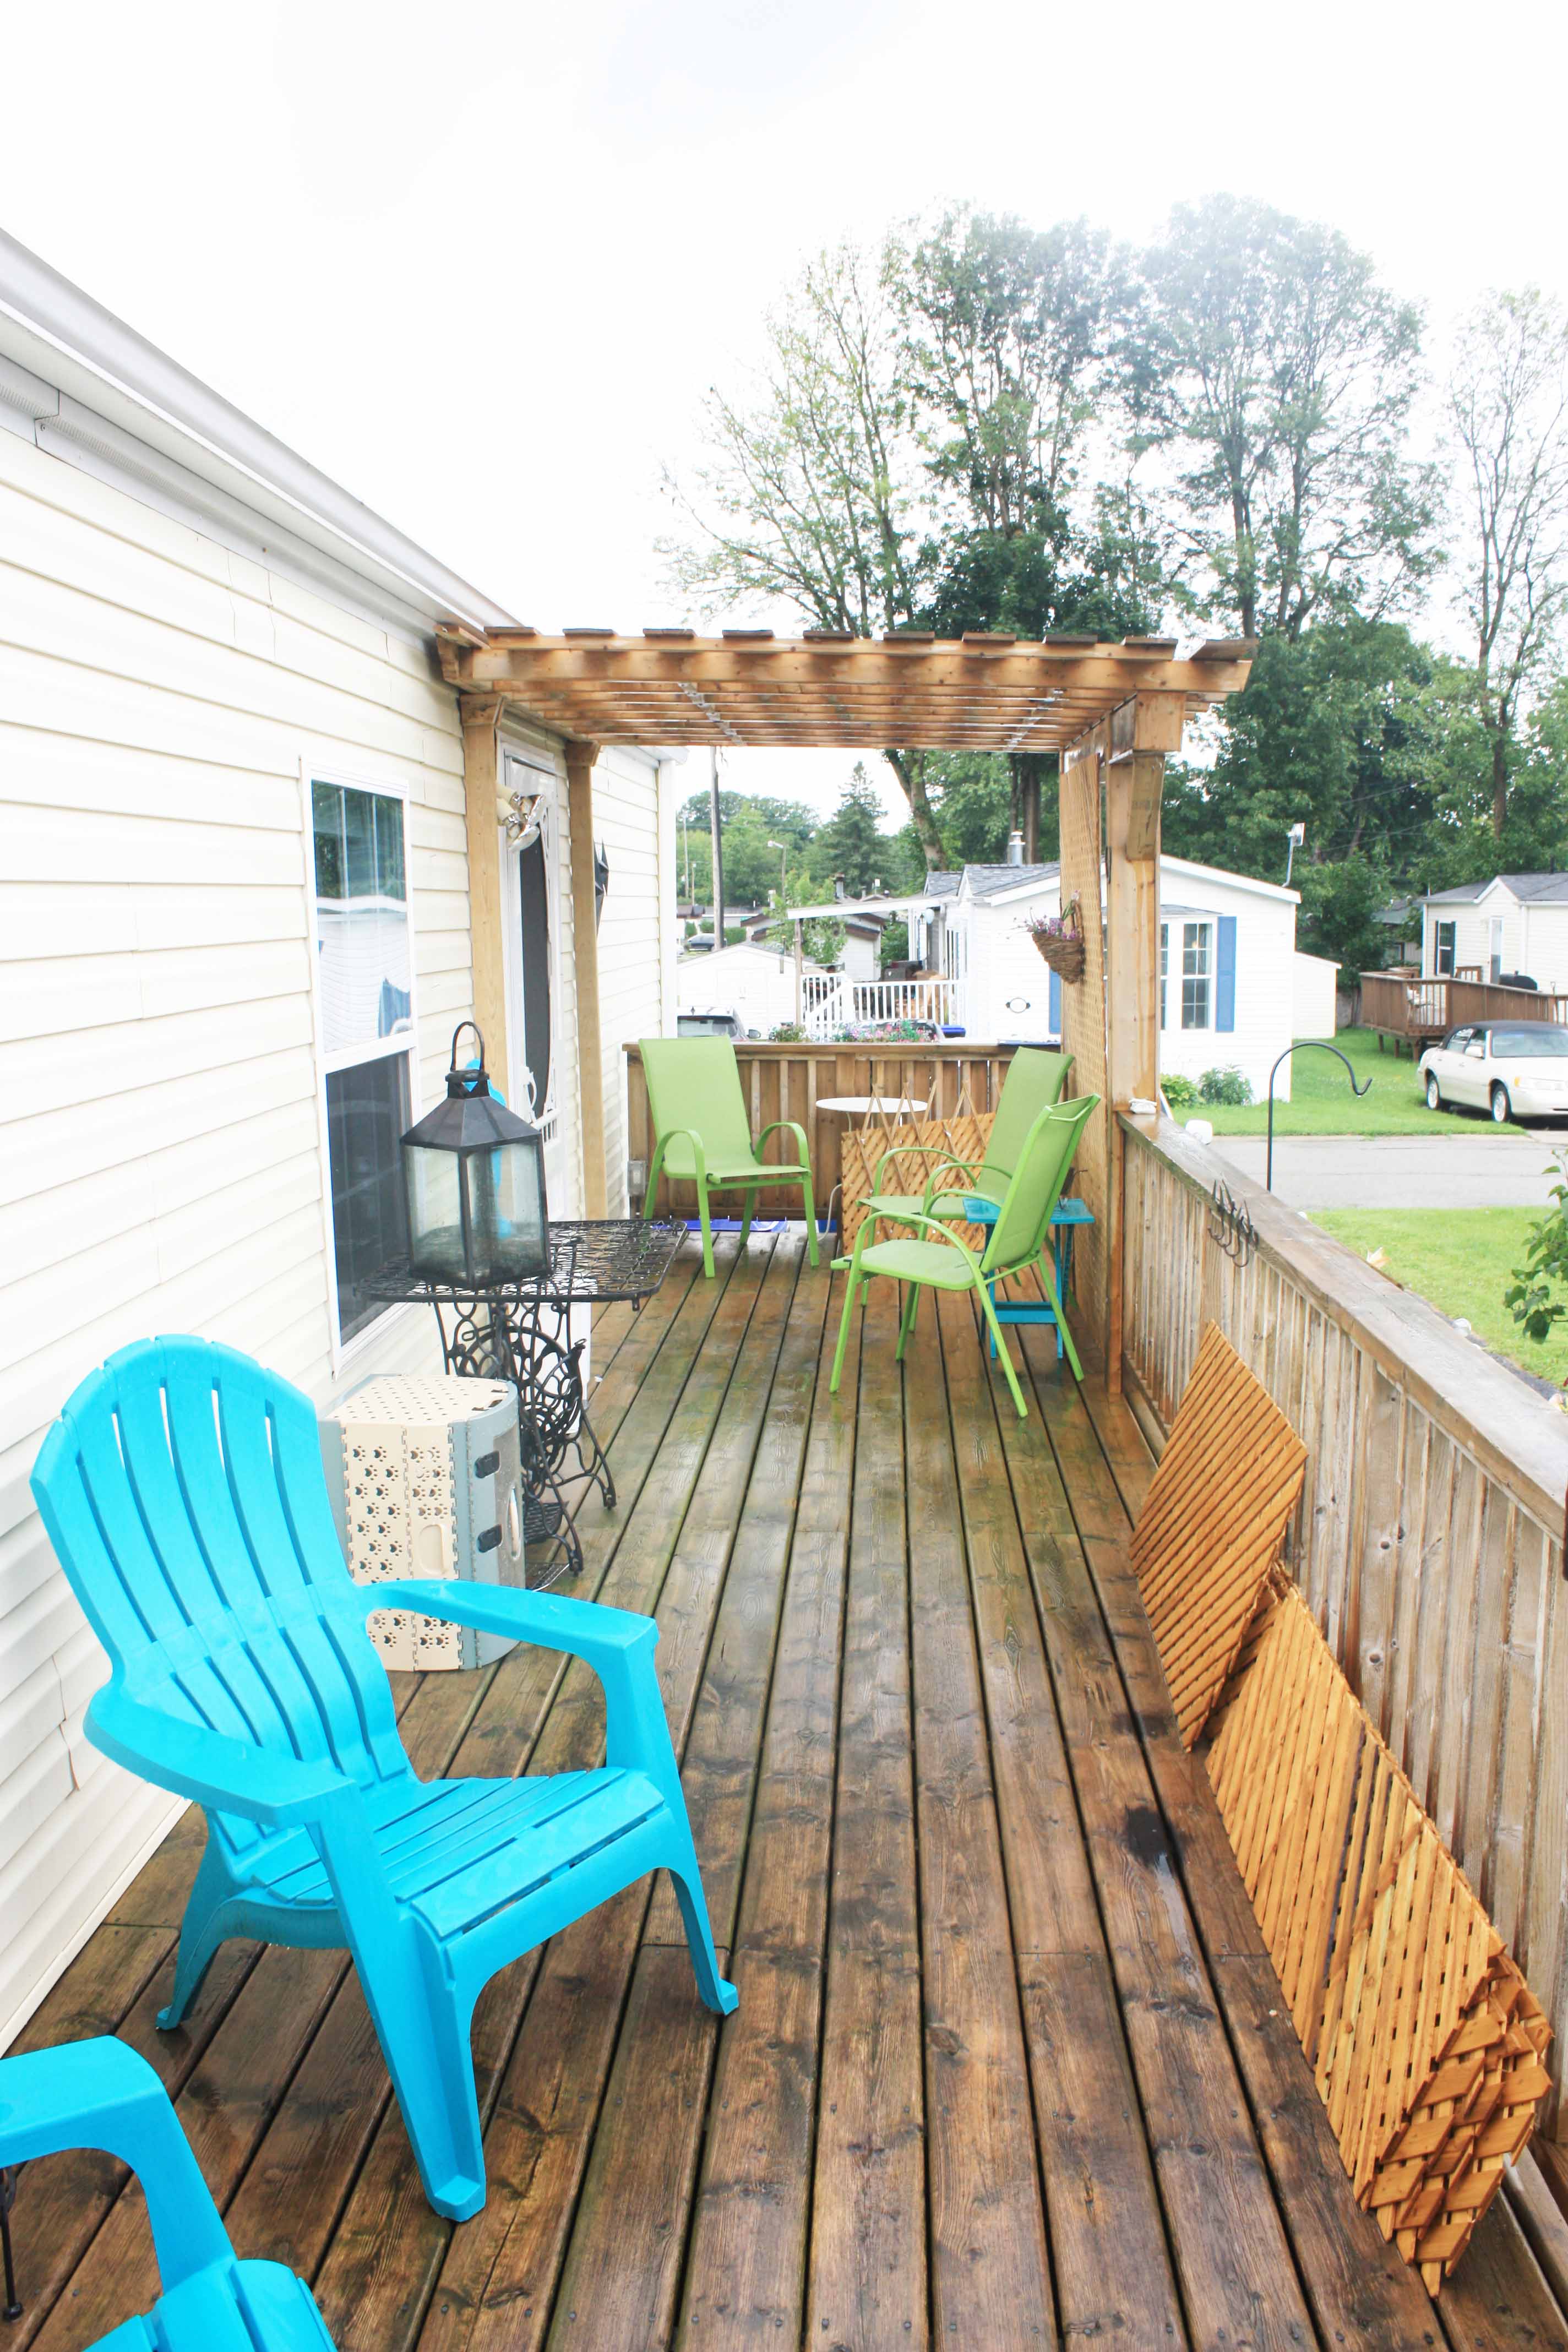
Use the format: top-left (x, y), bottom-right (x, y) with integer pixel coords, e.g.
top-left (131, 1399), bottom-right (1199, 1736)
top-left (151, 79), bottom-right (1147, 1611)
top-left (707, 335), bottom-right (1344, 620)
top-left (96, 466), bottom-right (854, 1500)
top-left (1124, 195), bottom-right (1434, 638)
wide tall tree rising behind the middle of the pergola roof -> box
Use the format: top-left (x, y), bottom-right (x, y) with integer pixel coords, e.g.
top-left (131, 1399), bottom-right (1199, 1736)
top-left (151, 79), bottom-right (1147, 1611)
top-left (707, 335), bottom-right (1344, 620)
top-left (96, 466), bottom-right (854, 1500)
top-left (665, 211), bottom-right (1152, 865)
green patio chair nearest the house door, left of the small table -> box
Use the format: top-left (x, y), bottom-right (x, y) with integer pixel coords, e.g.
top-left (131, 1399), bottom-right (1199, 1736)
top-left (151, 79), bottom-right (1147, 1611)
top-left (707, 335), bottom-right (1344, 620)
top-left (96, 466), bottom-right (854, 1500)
top-left (639, 1037), bottom-right (816, 1275)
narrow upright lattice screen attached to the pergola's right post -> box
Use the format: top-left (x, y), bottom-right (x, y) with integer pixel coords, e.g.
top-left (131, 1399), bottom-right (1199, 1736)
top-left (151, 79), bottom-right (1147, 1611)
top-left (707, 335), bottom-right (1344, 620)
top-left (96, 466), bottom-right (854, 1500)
top-left (1060, 753), bottom-right (1112, 1362)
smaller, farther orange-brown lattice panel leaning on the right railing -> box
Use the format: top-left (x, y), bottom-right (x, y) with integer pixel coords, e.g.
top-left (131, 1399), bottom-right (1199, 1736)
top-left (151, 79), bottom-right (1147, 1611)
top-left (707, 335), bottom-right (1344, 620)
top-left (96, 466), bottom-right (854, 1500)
top-left (1131, 1324), bottom-right (1307, 1747)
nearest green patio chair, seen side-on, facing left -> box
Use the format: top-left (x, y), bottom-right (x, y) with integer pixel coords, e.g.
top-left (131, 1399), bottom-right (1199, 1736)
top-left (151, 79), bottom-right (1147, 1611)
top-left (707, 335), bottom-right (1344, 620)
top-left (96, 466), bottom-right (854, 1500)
top-left (827, 1093), bottom-right (1100, 1420)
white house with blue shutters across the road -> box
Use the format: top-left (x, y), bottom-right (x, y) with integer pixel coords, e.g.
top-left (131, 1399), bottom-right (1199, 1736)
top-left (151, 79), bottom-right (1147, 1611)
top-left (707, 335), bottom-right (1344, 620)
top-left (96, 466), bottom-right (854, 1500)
top-left (910, 858), bottom-right (1335, 1101)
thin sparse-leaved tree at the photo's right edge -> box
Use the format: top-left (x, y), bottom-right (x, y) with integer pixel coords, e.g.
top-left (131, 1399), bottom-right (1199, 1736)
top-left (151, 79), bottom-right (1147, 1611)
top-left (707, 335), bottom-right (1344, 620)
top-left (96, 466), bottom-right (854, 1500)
top-left (1448, 287), bottom-right (1568, 840)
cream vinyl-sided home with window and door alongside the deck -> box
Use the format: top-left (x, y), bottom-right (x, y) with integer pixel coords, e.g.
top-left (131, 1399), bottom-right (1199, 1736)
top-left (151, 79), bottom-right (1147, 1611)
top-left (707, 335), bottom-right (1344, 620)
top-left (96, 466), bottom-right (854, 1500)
top-left (0, 237), bottom-right (674, 2046)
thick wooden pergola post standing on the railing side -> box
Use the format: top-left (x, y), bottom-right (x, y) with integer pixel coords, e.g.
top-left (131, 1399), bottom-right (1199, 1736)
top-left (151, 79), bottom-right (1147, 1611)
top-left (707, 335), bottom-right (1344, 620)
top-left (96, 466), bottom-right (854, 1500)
top-left (1105, 694), bottom-right (1183, 1397)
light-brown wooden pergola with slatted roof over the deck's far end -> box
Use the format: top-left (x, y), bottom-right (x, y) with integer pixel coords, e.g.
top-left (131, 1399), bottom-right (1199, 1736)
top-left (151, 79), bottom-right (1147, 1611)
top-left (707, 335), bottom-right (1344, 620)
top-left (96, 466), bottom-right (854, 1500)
top-left (437, 621), bottom-right (1253, 1383)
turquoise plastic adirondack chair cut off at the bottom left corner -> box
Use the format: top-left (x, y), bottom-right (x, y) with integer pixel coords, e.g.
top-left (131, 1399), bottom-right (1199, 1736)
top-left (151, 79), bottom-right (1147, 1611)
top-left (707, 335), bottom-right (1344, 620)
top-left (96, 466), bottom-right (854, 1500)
top-left (0, 2037), bottom-right (331, 2352)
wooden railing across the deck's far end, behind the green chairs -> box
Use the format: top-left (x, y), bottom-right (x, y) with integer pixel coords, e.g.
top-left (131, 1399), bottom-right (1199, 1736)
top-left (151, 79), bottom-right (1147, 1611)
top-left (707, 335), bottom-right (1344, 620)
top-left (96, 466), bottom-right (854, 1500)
top-left (625, 1039), bottom-right (1013, 1216)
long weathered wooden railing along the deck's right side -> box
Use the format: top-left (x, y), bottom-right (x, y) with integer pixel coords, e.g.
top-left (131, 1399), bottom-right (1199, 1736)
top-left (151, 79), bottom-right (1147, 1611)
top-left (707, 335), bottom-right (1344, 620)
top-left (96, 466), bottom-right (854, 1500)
top-left (1121, 1119), bottom-right (1568, 2138)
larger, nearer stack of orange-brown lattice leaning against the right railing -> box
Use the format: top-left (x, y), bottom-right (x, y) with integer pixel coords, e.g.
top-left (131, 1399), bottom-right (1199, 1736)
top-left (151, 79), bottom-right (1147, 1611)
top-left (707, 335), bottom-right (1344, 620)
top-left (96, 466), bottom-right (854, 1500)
top-left (1208, 1578), bottom-right (1549, 2291)
